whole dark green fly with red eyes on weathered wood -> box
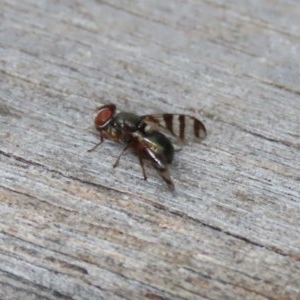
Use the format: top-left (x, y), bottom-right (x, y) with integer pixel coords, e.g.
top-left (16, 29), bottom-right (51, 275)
top-left (90, 104), bottom-right (206, 190)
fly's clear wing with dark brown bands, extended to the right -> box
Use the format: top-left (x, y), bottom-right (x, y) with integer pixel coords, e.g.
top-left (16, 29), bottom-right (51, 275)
top-left (142, 114), bottom-right (206, 142)
